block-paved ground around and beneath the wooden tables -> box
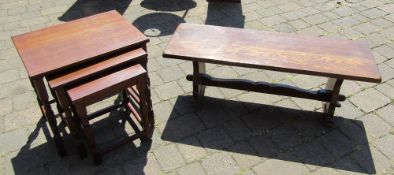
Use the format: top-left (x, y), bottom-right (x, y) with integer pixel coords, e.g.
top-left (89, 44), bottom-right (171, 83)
top-left (0, 0), bottom-right (394, 175)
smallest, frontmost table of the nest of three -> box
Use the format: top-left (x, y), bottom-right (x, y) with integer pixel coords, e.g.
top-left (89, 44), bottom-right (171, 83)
top-left (67, 64), bottom-right (153, 165)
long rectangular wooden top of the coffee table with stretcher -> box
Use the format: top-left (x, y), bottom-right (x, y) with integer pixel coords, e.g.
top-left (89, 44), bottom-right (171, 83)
top-left (163, 23), bottom-right (381, 82)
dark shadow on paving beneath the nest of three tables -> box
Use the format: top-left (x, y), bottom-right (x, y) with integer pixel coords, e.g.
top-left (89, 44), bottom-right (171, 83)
top-left (11, 96), bottom-right (151, 175)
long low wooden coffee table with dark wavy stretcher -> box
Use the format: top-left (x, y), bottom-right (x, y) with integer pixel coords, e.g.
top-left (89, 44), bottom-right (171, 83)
top-left (163, 23), bottom-right (381, 124)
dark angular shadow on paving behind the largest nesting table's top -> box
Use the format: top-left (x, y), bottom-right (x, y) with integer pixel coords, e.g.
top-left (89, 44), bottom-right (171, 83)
top-left (58, 0), bottom-right (132, 21)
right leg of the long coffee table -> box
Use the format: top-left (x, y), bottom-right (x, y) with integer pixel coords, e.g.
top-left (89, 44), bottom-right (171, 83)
top-left (323, 78), bottom-right (343, 125)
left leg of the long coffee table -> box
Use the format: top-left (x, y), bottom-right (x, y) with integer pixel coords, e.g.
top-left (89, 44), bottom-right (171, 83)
top-left (193, 61), bottom-right (205, 100)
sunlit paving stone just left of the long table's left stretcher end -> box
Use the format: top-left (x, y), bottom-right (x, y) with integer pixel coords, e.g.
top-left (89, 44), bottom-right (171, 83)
top-left (153, 81), bottom-right (183, 100)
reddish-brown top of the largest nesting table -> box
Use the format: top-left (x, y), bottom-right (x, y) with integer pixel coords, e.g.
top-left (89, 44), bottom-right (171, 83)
top-left (12, 10), bottom-right (149, 77)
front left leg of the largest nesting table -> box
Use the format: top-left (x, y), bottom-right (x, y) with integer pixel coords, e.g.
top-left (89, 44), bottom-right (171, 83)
top-left (31, 78), bottom-right (67, 157)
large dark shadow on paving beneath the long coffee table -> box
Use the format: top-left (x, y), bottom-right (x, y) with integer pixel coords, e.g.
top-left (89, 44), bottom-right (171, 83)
top-left (161, 96), bottom-right (375, 173)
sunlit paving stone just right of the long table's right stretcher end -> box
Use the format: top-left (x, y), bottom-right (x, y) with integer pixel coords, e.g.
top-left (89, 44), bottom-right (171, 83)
top-left (349, 88), bottom-right (390, 112)
